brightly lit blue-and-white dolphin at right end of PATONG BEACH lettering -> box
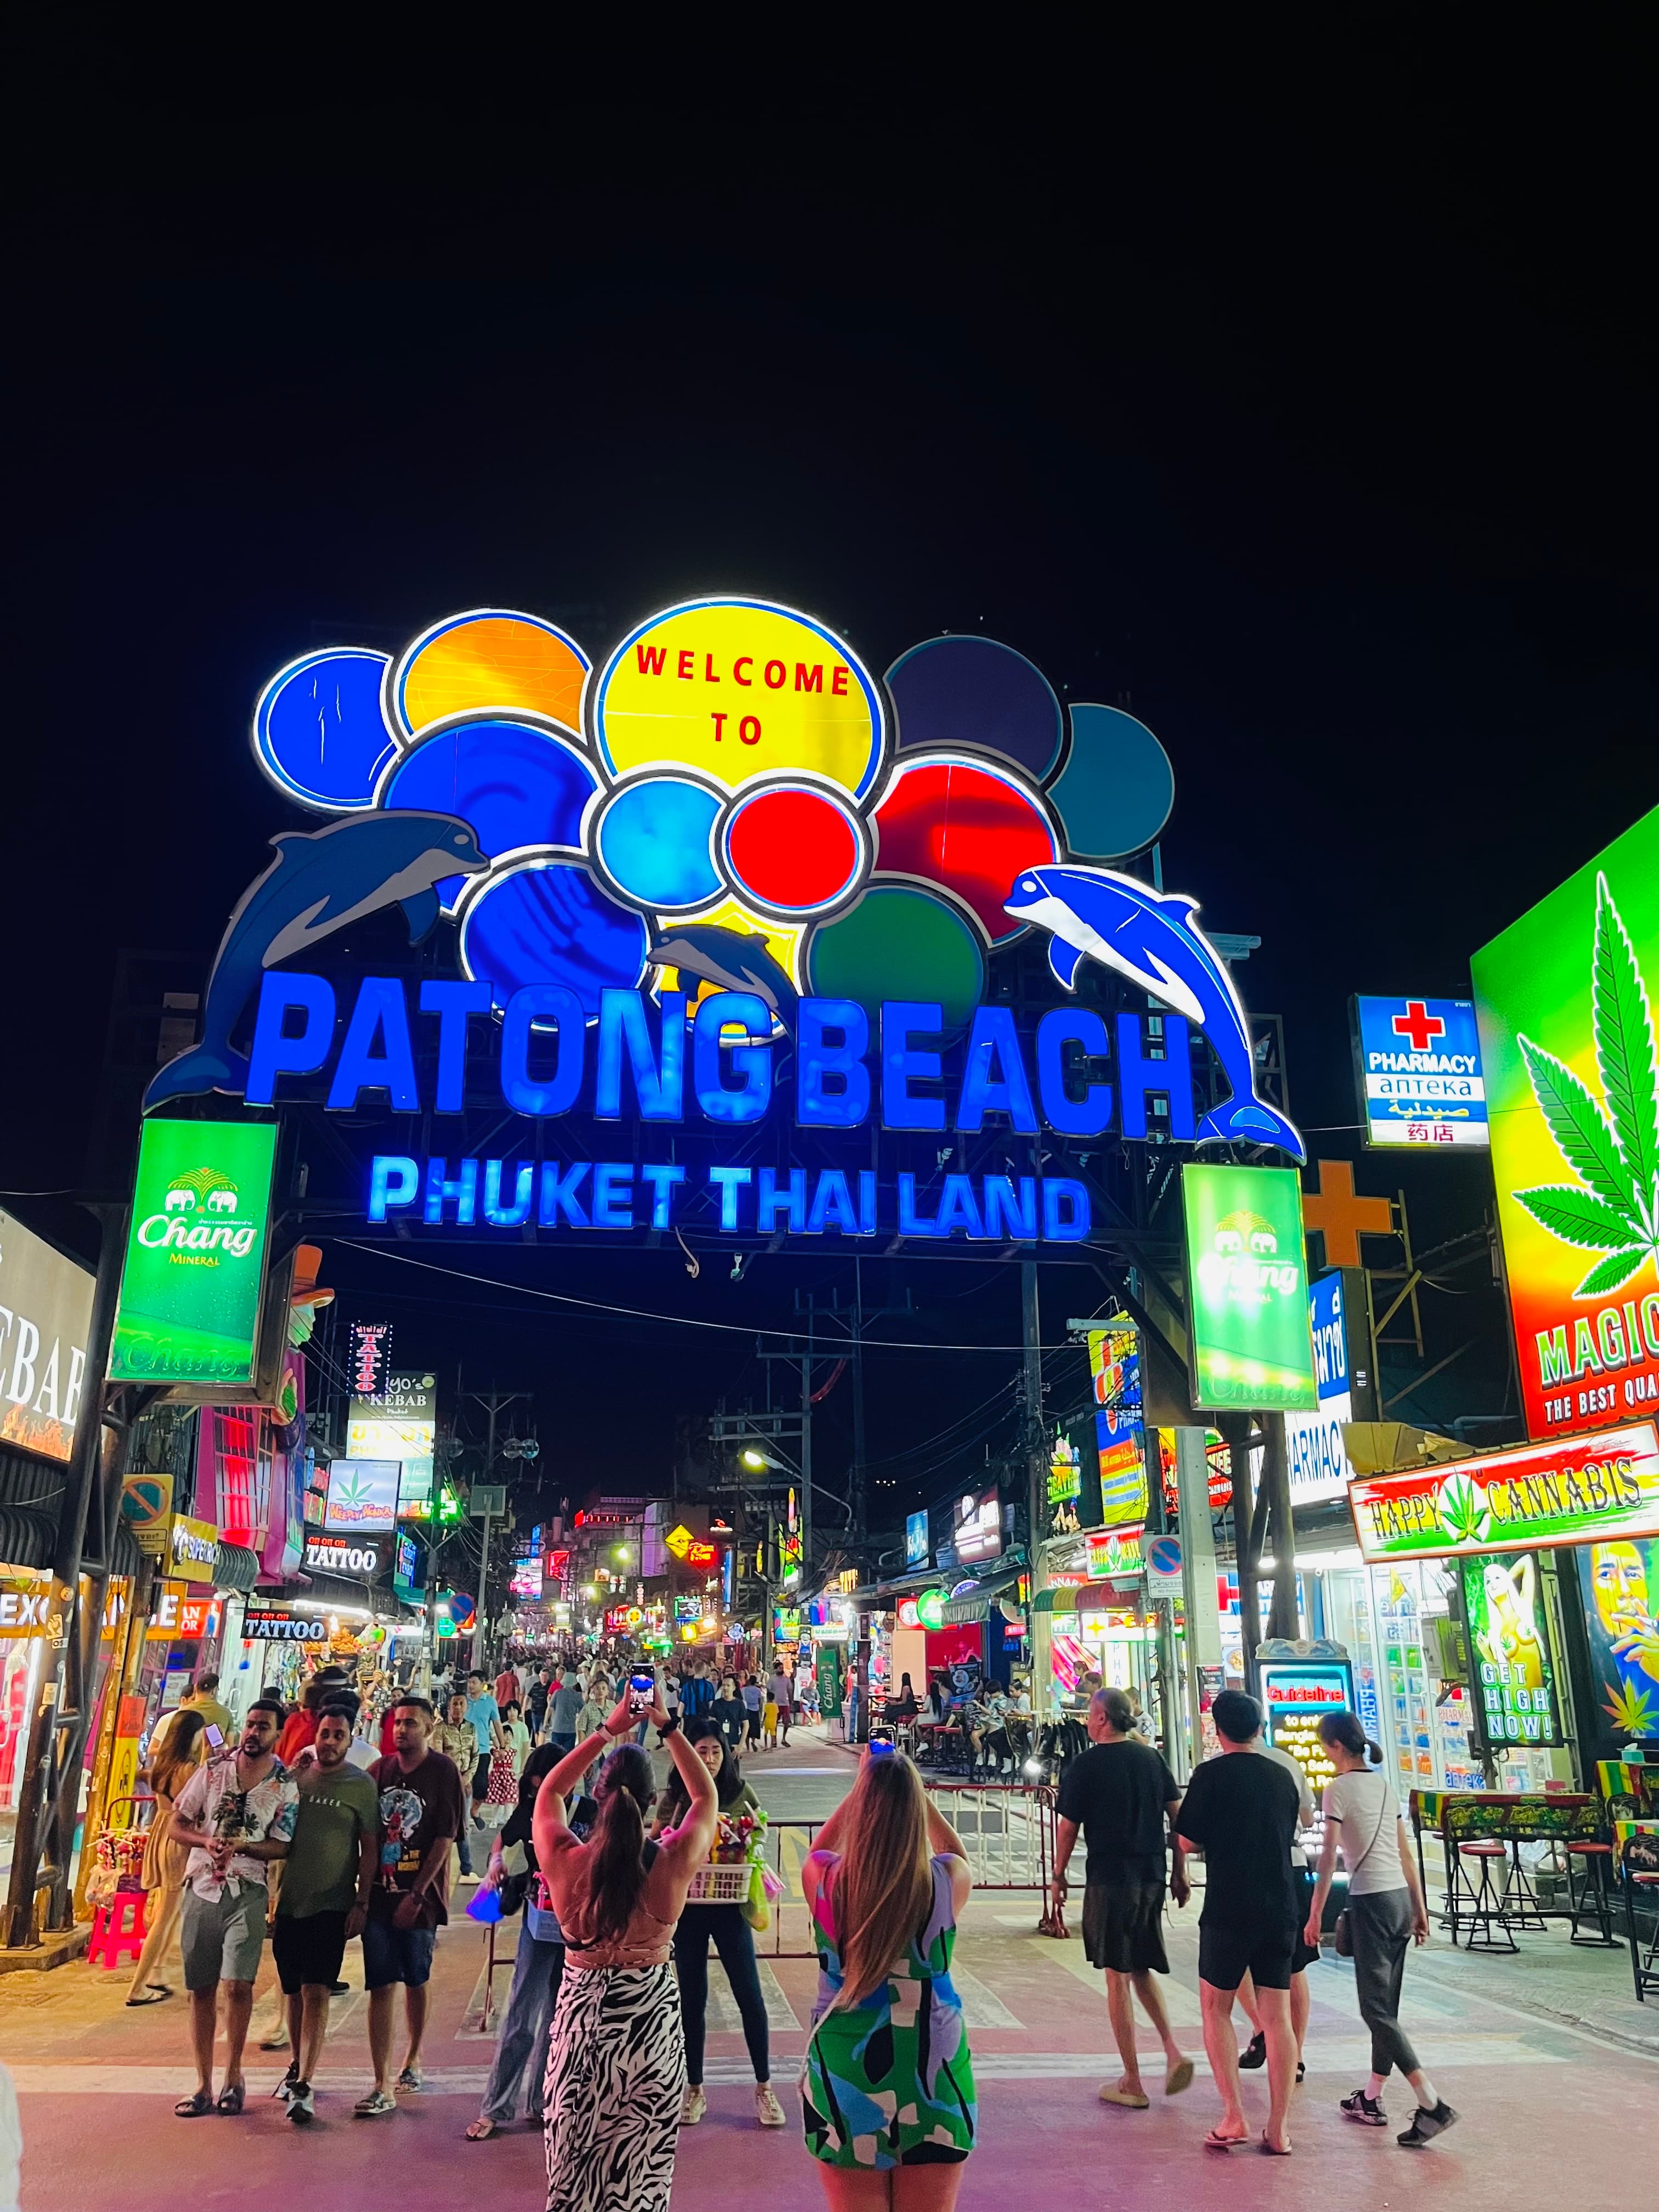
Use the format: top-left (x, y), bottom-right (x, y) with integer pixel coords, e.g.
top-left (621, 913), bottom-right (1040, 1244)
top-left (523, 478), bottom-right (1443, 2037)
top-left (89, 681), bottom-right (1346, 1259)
top-left (1005, 867), bottom-right (1307, 1161)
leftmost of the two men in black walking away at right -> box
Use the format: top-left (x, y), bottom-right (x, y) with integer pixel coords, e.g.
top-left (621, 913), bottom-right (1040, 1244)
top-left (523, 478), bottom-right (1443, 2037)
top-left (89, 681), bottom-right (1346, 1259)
top-left (1053, 1690), bottom-right (1192, 2113)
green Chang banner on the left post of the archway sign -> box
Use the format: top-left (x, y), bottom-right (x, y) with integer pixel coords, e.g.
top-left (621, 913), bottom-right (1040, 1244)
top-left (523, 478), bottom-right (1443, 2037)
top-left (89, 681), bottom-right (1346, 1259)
top-left (109, 1121), bottom-right (276, 1387)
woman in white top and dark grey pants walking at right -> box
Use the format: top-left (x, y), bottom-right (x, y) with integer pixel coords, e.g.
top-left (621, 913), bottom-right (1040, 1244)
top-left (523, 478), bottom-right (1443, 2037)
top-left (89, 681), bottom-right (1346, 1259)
top-left (1303, 1712), bottom-right (1458, 2150)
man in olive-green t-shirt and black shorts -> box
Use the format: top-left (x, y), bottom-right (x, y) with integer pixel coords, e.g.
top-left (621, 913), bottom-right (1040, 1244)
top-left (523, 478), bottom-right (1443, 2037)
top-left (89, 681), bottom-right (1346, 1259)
top-left (270, 1699), bottom-right (381, 2126)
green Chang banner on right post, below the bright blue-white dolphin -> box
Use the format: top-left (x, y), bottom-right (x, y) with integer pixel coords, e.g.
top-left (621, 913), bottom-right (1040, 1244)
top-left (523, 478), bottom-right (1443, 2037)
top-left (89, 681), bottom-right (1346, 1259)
top-left (1181, 1161), bottom-right (1318, 1411)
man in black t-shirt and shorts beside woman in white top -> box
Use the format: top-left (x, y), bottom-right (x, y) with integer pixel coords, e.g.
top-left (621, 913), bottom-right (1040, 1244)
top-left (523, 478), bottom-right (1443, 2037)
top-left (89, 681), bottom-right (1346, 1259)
top-left (1177, 1690), bottom-right (1301, 2154)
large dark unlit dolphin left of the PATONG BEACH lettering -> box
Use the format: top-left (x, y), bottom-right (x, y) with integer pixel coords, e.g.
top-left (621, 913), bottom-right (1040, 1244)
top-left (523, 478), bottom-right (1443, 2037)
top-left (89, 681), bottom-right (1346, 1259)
top-left (144, 814), bottom-right (489, 1113)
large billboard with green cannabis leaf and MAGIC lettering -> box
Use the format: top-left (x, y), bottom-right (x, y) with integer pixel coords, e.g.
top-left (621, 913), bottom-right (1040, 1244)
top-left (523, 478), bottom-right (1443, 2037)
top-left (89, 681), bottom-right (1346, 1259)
top-left (1471, 810), bottom-right (1659, 1438)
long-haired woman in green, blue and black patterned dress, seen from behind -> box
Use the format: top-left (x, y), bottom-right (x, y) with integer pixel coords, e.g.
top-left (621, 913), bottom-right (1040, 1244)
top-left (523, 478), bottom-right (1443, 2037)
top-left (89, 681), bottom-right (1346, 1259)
top-left (801, 1745), bottom-right (978, 2212)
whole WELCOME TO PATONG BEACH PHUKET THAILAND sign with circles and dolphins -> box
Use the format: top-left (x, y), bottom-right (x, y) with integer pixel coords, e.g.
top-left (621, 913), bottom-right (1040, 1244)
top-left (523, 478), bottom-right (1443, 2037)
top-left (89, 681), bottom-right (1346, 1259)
top-left (146, 597), bottom-right (1303, 1239)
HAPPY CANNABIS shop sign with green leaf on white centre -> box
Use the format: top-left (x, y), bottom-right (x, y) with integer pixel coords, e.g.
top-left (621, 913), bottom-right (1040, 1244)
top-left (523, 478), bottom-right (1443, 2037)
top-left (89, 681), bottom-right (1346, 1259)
top-left (1347, 1420), bottom-right (1659, 1562)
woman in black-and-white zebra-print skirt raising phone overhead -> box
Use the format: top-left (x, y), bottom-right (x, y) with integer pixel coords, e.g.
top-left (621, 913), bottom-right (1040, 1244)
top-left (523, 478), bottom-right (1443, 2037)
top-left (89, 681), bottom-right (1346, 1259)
top-left (535, 1688), bottom-right (719, 2212)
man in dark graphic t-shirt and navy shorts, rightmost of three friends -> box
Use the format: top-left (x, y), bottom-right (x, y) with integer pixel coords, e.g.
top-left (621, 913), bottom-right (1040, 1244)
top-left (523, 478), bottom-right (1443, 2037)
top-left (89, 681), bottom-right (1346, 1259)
top-left (356, 1697), bottom-right (467, 2119)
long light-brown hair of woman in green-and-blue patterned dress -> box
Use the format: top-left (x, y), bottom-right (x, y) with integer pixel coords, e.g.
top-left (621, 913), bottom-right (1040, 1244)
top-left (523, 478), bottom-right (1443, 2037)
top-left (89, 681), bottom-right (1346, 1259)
top-left (830, 1752), bottom-right (934, 2011)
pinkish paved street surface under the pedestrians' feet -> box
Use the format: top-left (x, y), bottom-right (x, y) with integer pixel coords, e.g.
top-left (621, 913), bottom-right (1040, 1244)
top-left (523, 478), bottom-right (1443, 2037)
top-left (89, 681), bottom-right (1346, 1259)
top-left (0, 1736), bottom-right (1659, 2212)
